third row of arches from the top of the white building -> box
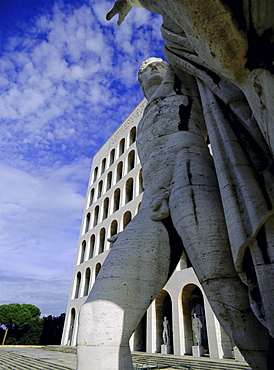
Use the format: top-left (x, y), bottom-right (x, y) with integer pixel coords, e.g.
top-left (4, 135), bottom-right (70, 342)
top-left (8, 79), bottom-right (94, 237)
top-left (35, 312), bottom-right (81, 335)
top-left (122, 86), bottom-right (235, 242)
top-left (83, 175), bottom-right (144, 234)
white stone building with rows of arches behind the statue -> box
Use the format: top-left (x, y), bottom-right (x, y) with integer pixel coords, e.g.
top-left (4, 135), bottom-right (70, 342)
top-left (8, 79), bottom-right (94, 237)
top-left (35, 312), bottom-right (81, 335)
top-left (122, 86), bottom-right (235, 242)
top-left (61, 99), bottom-right (237, 358)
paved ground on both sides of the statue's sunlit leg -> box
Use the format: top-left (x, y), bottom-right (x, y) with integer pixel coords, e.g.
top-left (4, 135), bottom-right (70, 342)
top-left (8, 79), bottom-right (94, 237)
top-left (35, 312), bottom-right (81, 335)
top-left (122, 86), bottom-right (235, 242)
top-left (0, 346), bottom-right (250, 370)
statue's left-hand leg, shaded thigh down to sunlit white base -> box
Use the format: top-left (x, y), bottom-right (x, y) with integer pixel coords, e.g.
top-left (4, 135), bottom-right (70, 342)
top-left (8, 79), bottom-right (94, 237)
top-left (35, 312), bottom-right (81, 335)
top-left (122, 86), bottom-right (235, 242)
top-left (77, 201), bottom-right (170, 370)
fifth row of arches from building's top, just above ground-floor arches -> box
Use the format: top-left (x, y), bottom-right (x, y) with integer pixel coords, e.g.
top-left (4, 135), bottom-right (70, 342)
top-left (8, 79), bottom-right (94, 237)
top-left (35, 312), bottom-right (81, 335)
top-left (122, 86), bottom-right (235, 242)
top-left (72, 262), bottom-right (102, 299)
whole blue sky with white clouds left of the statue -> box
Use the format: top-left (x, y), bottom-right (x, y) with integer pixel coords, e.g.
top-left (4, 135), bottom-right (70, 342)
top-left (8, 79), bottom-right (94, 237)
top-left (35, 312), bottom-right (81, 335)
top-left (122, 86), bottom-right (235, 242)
top-left (0, 0), bottom-right (163, 315)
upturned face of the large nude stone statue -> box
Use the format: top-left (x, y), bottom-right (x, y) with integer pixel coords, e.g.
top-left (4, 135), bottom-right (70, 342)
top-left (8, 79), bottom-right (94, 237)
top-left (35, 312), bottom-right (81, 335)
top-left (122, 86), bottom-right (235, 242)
top-left (141, 61), bottom-right (166, 92)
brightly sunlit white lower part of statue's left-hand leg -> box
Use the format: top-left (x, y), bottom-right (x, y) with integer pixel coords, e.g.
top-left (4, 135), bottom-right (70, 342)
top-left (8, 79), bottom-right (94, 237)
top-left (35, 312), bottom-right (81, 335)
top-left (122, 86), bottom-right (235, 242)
top-left (77, 300), bottom-right (133, 370)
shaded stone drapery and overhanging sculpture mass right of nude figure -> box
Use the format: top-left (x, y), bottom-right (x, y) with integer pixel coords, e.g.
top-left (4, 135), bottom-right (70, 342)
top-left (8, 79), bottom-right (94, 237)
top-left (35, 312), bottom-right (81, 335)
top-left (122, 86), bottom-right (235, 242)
top-left (103, 0), bottom-right (274, 367)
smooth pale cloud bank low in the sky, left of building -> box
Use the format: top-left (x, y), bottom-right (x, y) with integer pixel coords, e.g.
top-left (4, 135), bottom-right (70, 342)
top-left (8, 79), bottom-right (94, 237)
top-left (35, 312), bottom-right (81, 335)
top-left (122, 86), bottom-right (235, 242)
top-left (0, 160), bottom-right (89, 314)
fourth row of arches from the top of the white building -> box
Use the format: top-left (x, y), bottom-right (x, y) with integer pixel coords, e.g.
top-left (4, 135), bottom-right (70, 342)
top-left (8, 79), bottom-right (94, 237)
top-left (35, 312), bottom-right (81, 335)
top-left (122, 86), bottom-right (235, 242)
top-left (77, 210), bottom-right (141, 264)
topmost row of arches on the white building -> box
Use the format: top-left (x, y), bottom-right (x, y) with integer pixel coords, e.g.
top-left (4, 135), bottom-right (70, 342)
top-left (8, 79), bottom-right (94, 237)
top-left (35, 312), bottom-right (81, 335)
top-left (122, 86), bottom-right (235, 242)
top-left (93, 126), bottom-right (136, 182)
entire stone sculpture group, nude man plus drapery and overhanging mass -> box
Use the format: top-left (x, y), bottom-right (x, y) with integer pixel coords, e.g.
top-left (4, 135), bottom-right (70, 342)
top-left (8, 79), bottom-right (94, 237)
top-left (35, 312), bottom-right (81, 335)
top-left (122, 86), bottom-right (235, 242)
top-left (75, 0), bottom-right (274, 370)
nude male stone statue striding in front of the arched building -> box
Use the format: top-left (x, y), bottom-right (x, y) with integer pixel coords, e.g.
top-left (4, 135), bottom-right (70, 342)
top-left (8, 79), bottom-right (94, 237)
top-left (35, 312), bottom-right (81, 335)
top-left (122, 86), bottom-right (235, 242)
top-left (78, 58), bottom-right (269, 370)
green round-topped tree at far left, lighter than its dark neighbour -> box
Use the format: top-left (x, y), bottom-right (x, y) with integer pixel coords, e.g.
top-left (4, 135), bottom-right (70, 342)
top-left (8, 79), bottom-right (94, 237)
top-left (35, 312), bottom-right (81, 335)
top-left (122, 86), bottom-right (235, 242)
top-left (0, 303), bottom-right (41, 344)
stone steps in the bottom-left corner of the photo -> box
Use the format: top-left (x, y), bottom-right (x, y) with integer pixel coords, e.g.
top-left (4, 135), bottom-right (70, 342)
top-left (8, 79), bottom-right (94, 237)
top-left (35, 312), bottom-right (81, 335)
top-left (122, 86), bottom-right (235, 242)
top-left (0, 351), bottom-right (71, 370)
